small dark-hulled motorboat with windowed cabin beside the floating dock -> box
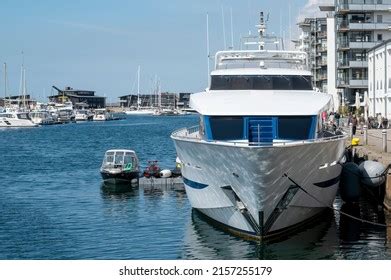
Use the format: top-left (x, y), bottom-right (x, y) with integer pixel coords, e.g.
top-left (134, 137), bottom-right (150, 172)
top-left (100, 149), bottom-right (140, 184)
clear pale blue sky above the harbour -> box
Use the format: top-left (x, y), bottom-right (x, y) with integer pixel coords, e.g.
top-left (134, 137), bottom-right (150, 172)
top-left (0, 0), bottom-right (314, 102)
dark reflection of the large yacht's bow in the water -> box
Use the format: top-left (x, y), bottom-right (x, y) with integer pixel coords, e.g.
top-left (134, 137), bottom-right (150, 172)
top-left (182, 210), bottom-right (338, 259)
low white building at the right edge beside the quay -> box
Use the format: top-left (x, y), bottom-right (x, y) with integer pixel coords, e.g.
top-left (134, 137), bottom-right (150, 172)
top-left (368, 40), bottom-right (391, 119)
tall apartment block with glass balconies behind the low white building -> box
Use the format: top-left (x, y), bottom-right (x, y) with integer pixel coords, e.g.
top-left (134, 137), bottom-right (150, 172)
top-left (335, 0), bottom-right (391, 105)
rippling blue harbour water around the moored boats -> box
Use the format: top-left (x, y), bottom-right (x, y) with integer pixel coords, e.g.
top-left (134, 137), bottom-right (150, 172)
top-left (0, 116), bottom-right (391, 259)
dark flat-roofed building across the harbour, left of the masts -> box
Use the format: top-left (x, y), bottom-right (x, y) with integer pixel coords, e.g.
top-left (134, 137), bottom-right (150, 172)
top-left (49, 86), bottom-right (106, 109)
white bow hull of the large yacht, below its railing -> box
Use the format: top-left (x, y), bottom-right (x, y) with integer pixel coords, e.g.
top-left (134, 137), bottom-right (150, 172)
top-left (172, 136), bottom-right (345, 240)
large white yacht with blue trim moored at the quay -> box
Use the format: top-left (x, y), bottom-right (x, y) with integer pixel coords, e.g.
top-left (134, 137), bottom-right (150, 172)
top-left (171, 17), bottom-right (347, 239)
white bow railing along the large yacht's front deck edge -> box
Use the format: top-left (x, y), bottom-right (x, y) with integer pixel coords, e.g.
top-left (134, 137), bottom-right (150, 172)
top-left (171, 125), bottom-right (348, 148)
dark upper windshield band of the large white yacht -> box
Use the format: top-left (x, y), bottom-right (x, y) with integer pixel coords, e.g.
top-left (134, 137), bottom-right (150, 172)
top-left (210, 75), bottom-right (312, 90)
